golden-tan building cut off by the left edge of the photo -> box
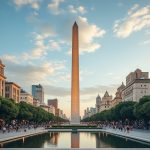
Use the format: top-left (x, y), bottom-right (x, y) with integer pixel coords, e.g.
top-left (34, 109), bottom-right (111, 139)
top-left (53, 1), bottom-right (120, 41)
top-left (0, 60), bottom-right (6, 97)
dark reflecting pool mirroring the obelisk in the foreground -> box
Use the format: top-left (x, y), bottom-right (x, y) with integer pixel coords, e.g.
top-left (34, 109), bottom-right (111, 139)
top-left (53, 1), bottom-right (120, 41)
top-left (1, 132), bottom-right (150, 148)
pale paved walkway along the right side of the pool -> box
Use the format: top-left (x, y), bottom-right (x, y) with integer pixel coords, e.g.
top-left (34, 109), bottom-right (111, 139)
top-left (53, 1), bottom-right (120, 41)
top-left (102, 128), bottom-right (150, 143)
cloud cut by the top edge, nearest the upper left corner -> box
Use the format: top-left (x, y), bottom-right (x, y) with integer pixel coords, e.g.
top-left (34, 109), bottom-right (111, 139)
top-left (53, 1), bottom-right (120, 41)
top-left (13, 0), bottom-right (41, 10)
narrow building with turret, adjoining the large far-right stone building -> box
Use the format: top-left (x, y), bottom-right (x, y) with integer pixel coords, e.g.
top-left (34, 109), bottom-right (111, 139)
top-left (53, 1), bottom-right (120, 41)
top-left (111, 82), bottom-right (125, 107)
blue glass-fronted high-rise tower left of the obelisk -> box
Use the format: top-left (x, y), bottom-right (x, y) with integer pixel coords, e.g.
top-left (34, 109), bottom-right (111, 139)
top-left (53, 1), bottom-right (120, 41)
top-left (32, 84), bottom-right (44, 104)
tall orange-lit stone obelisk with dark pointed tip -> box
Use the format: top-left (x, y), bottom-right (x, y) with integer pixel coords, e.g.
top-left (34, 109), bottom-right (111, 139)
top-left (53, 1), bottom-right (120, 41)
top-left (71, 22), bottom-right (80, 124)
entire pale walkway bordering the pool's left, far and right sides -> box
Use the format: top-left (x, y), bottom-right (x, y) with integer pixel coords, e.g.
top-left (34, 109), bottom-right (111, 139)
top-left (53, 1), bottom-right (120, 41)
top-left (0, 128), bottom-right (150, 143)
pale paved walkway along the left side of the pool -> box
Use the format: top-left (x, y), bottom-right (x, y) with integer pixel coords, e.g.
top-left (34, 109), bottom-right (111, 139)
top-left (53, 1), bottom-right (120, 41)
top-left (0, 128), bottom-right (47, 143)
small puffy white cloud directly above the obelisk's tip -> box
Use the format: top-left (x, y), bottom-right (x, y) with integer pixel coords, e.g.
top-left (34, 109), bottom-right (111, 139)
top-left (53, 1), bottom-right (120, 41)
top-left (68, 5), bottom-right (87, 14)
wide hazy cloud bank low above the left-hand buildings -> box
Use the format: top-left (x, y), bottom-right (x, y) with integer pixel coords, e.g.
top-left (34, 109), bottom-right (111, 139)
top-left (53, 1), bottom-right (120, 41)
top-left (2, 56), bottom-right (65, 87)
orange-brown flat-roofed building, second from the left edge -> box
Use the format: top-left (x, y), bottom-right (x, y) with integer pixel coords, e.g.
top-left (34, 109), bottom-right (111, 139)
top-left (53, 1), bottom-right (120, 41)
top-left (5, 82), bottom-right (21, 103)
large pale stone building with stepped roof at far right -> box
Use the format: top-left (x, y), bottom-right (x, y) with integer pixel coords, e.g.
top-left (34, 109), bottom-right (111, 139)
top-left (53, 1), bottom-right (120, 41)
top-left (122, 69), bottom-right (150, 102)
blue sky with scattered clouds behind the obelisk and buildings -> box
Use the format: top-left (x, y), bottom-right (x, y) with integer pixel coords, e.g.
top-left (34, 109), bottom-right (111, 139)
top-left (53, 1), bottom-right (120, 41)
top-left (0, 0), bottom-right (150, 117)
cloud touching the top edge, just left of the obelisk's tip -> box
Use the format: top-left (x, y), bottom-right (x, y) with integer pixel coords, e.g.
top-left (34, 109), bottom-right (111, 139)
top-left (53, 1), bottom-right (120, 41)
top-left (48, 0), bottom-right (65, 15)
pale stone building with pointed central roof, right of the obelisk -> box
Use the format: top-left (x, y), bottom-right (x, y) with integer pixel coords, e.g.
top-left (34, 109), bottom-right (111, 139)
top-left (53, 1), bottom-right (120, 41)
top-left (100, 91), bottom-right (112, 112)
